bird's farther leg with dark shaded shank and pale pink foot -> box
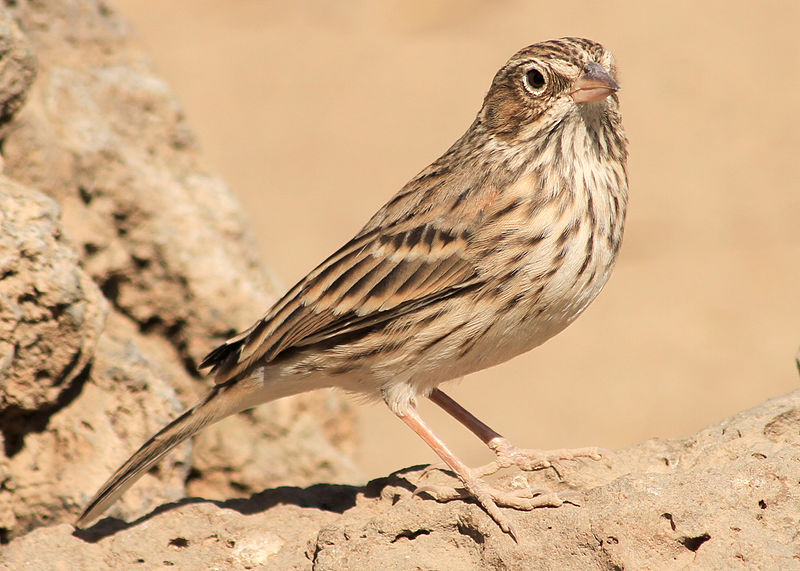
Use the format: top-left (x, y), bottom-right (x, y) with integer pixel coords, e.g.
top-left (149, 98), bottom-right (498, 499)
top-left (428, 389), bottom-right (603, 477)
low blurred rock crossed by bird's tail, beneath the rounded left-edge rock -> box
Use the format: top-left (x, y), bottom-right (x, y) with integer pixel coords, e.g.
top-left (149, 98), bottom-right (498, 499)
top-left (0, 314), bottom-right (189, 537)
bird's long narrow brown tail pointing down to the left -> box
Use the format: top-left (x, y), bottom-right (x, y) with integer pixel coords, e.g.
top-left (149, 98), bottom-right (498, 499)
top-left (75, 380), bottom-right (264, 528)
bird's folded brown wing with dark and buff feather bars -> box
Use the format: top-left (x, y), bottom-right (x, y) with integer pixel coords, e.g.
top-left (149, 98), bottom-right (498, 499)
top-left (200, 218), bottom-right (480, 383)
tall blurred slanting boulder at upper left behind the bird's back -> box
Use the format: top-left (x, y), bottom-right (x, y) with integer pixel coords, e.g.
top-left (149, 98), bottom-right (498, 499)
top-left (3, 0), bottom-right (275, 364)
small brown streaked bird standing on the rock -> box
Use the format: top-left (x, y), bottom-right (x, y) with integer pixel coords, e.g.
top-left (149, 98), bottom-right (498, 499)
top-left (77, 38), bottom-right (628, 537)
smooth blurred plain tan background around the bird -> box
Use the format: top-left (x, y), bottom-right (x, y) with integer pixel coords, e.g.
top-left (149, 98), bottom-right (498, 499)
top-left (111, 0), bottom-right (800, 477)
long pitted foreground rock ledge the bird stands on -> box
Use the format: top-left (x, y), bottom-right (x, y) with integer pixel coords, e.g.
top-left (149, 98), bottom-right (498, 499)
top-left (0, 391), bottom-right (800, 570)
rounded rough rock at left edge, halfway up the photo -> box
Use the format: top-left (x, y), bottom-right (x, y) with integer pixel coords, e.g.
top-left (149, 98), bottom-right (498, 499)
top-left (0, 176), bottom-right (107, 420)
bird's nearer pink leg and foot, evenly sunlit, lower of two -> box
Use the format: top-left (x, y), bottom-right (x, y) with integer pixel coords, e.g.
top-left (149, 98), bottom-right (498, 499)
top-left (397, 407), bottom-right (564, 541)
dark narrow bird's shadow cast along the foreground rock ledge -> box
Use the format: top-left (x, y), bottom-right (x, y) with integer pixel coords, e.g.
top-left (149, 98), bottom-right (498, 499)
top-left (72, 466), bottom-right (426, 543)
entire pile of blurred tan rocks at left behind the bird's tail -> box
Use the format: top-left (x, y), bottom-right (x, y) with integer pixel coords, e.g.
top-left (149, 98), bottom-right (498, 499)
top-left (0, 0), bottom-right (360, 541)
